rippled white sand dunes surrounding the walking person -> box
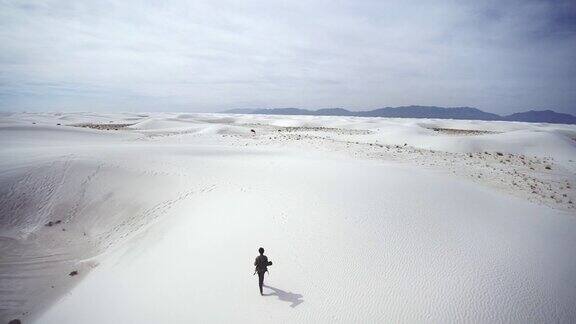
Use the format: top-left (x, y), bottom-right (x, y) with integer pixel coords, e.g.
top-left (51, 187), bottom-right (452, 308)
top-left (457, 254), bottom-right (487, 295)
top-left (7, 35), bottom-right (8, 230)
top-left (0, 113), bottom-right (576, 323)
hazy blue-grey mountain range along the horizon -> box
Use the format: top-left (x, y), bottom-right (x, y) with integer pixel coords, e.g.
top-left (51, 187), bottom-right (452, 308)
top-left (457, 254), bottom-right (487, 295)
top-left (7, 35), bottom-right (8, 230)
top-left (225, 106), bottom-right (576, 124)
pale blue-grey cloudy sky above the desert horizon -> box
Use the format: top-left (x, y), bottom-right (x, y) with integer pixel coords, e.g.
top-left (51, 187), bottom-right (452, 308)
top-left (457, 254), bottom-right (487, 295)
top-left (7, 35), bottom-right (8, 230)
top-left (0, 0), bottom-right (576, 114)
